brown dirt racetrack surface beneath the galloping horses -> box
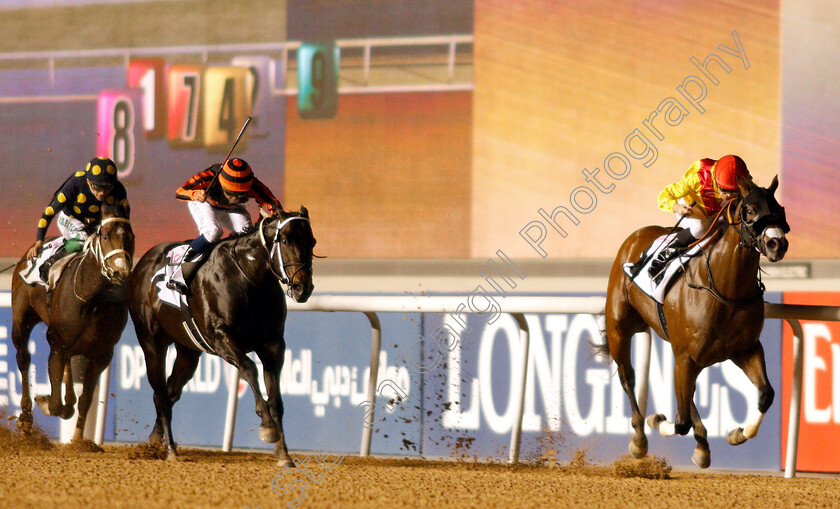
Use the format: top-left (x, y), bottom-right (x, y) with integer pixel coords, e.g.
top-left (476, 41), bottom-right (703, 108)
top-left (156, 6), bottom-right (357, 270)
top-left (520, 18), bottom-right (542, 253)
top-left (0, 428), bottom-right (840, 509)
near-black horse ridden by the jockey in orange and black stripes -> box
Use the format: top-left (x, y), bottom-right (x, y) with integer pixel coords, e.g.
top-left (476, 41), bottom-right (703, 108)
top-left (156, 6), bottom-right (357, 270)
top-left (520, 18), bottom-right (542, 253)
top-left (128, 207), bottom-right (315, 466)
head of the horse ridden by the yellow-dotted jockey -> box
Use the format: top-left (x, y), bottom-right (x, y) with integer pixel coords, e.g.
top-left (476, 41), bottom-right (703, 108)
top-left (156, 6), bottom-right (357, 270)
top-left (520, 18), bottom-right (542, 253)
top-left (89, 204), bottom-right (134, 285)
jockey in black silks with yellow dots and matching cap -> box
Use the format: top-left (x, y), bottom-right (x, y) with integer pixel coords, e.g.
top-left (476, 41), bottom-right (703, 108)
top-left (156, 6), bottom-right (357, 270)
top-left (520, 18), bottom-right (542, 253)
top-left (26, 157), bottom-right (129, 279)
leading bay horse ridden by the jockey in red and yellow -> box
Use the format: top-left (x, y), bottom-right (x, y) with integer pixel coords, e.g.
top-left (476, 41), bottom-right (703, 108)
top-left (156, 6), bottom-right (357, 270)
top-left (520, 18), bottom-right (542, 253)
top-left (605, 178), bottom-right (790, 468)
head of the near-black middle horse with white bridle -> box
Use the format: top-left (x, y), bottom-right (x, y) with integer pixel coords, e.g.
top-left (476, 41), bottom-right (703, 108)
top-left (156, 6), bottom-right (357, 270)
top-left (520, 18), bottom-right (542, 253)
top-left (259, 206), bottom-right (315, 302)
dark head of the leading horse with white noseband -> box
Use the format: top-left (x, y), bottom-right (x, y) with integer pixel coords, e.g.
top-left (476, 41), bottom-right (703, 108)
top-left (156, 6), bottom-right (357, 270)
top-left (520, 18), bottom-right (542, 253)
top-left (739, 176), bottom-right (790, 262)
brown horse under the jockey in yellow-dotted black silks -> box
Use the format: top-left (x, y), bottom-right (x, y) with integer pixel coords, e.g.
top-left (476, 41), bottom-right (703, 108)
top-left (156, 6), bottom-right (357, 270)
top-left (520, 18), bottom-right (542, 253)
top-left (12, 204), bottom-right (134, 440)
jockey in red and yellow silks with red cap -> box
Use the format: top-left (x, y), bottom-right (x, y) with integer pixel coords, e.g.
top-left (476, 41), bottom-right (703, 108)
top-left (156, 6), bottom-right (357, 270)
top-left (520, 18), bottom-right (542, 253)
top-left (650, 155), bottom-right (752, 278)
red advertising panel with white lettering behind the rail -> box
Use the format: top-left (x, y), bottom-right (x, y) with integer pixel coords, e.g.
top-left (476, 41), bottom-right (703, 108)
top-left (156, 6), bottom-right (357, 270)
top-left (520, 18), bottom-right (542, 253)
top-left (782, 292), bottom-right (840, 472)
